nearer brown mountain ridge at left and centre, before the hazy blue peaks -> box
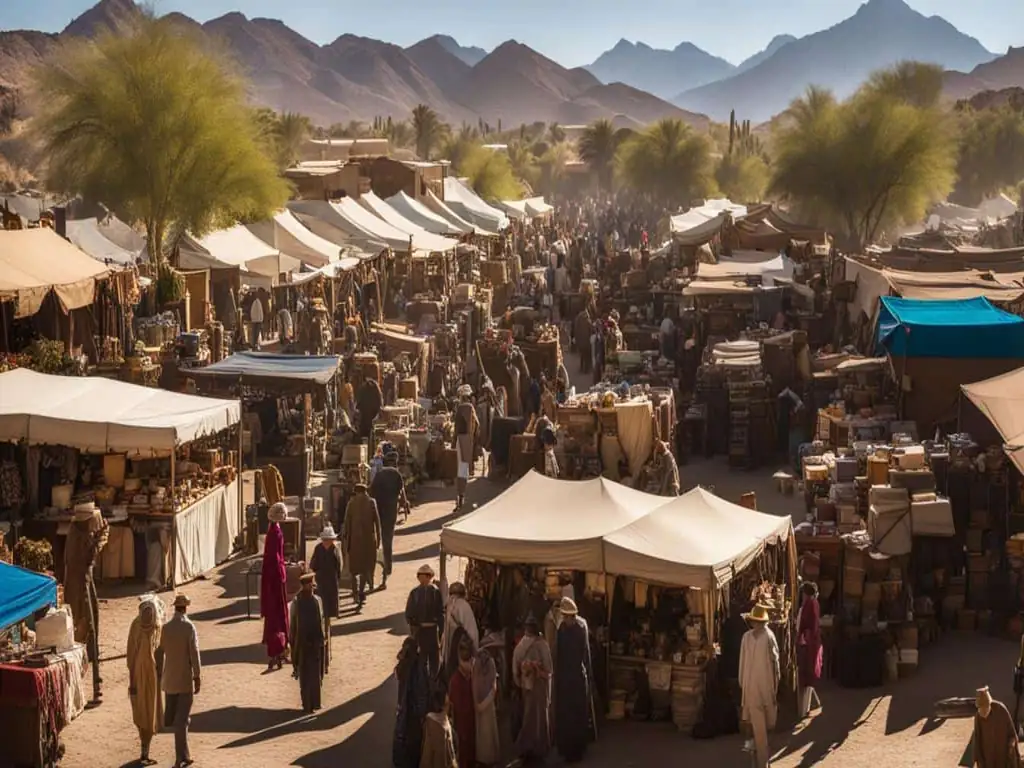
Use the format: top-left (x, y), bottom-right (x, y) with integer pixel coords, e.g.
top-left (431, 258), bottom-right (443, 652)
top-left (0, 0), bottom-right (709, 128)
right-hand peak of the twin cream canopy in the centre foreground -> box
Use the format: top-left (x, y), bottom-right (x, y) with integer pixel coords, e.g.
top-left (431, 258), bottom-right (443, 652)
top-left (604, 487), bottom-right (793, 590)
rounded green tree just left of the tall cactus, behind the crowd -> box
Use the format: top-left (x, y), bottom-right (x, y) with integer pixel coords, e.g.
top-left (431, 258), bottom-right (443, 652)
top-left (616, 118), bottom-right (714, 207)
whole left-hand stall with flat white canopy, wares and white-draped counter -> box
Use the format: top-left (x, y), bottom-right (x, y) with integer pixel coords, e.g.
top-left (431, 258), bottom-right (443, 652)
top-left (0, 369), bottom-right (242, 586)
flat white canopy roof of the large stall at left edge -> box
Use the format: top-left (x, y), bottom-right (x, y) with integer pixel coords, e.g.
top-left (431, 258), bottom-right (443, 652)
top-left (0, 368), bottom-right (241, 456)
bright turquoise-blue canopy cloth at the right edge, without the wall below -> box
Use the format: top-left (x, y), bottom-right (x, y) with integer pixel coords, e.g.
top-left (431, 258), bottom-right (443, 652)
top-left (876, 296), bottom-right (1024, 359)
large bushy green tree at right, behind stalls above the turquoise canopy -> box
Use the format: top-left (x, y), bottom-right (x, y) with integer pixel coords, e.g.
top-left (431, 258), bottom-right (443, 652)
top-left (769, 63), bottom-right (955, 248)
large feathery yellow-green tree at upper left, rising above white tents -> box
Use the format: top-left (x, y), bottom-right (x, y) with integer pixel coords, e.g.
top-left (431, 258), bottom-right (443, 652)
top-left (35, 17), bottom-right (288, 260)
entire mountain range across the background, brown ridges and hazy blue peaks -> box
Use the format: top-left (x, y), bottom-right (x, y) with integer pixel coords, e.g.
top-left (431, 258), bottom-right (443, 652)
top-left (0, 0), bottom-right (1024, 128)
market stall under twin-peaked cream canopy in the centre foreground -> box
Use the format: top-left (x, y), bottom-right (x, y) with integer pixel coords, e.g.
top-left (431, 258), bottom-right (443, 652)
top-left (441, 472), bottom-right (796, 729)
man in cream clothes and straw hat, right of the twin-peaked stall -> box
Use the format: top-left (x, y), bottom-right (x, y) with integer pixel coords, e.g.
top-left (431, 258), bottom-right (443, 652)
top-left (739, 603), bottom-right (779, 768)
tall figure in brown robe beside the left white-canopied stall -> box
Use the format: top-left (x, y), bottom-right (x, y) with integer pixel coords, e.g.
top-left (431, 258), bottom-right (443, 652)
top-left (65, 502), bottom-right (111, 705)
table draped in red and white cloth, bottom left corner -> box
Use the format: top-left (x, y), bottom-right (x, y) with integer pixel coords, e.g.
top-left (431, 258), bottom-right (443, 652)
top-left (0, 645), bottom-right (86, 768)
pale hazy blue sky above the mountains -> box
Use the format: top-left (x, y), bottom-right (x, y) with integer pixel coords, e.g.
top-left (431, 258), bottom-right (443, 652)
top-left (0, 0), bottom-right (1024, 66)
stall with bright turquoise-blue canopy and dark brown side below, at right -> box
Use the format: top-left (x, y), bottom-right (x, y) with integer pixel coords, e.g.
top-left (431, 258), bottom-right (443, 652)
top-left (874, 296), bottom-right (1024, 434)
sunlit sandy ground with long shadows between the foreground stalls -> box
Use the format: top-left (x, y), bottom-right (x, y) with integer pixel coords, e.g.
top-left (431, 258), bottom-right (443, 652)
top-left (56, 346), bottom-right (1017, 768)
